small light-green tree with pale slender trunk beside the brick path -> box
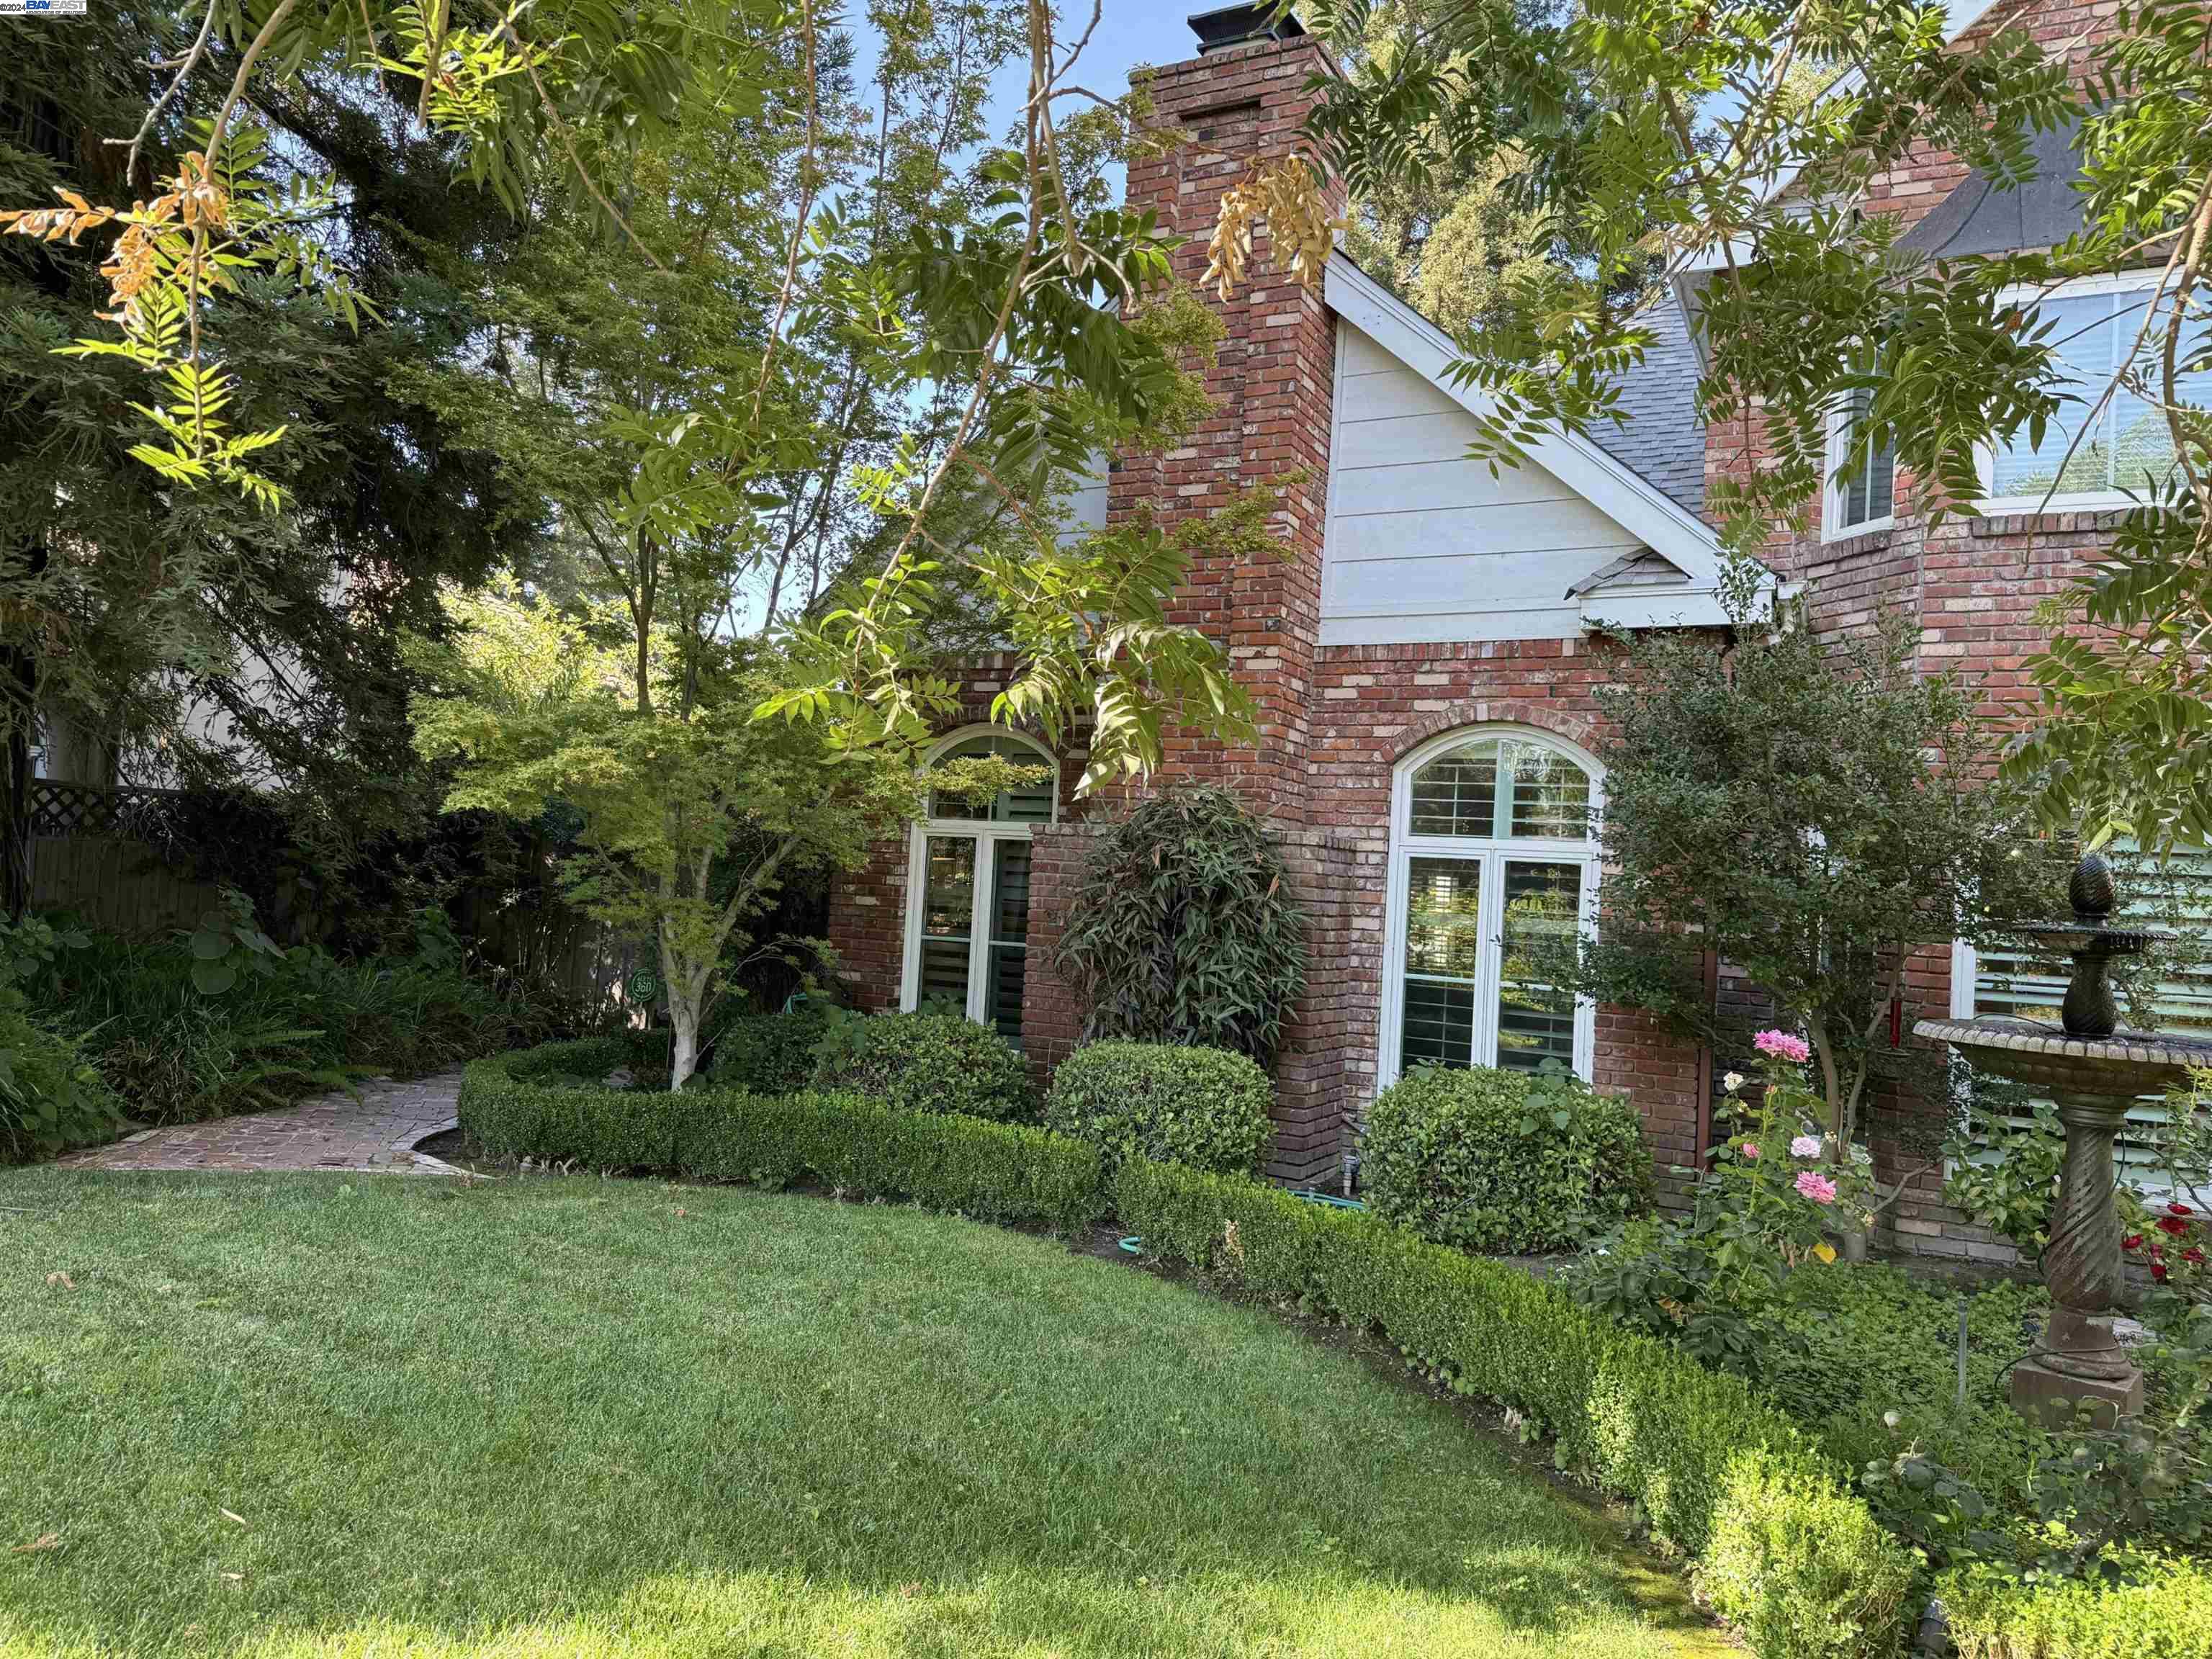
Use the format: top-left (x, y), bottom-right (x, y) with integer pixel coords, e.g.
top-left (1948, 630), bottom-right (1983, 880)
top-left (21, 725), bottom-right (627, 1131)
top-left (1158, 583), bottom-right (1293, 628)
top-left (411, 580), bottom-right (946, 1088)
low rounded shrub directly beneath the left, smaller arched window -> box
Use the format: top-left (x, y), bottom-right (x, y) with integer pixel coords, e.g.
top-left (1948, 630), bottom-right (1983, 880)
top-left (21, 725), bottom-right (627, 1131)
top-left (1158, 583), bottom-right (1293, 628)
top-left (814, 1013), bottom-right (1038, 1122)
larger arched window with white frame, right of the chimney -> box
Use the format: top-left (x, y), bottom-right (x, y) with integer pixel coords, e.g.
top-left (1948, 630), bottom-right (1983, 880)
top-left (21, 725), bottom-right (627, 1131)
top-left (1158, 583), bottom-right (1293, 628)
top-left (1380, 726), bottom-right (1599, 1084)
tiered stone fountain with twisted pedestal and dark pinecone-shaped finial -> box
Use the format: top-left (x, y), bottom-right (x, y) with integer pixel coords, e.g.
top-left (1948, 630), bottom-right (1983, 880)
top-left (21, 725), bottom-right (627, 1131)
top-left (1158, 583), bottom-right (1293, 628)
top-left (1913, 854), bottom-right (2212, 1420)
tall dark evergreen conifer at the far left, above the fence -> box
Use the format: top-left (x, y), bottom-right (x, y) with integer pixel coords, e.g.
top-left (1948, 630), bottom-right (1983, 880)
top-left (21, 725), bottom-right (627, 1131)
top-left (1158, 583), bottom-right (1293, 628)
top-left (0, 0), bottom-right (570, 925)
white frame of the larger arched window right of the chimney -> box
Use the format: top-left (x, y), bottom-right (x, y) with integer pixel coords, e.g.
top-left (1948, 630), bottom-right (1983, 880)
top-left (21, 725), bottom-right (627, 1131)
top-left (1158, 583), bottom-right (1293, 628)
top-left (1376, 724), bottom-right (1606, 1088)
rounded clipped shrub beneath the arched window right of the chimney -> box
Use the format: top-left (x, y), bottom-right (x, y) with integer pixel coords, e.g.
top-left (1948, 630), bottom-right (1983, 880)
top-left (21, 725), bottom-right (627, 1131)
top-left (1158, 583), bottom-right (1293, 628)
top-left (1360, 1066), bottom-right (1650, 1254)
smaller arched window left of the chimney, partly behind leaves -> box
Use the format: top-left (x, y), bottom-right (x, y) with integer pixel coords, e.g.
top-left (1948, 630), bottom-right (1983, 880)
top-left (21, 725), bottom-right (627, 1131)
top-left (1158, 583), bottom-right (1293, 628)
top-left (898, 730), bottom-right (1059, 1046)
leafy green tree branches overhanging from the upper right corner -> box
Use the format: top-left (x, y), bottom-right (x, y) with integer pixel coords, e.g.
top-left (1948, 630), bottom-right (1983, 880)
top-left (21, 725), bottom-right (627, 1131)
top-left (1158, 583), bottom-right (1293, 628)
top-left (1217, 0), bottom-right (2212, 848)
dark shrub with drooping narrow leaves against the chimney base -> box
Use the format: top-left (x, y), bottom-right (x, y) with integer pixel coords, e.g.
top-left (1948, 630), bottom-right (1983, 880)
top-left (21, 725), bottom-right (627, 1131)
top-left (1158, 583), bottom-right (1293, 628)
top-left (1057, 783), bottom-right (1305, 1066)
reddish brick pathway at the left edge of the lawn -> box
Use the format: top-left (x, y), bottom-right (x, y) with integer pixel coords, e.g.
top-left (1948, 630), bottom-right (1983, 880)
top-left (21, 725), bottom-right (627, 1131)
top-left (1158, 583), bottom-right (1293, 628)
top-left (62, 1071), bottom-right (460, 1174)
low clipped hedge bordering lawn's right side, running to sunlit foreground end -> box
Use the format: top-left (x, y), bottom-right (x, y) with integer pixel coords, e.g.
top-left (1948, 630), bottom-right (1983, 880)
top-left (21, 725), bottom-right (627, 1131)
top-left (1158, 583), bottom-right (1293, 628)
top-left (1112, 1164), bottom-right (1913, 1659)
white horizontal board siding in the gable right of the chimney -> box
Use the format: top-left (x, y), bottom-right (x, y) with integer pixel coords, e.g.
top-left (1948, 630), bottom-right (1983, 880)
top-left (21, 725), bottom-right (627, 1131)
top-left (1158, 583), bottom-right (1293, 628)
top-left (1321, 316), bottom-right (1641, 646)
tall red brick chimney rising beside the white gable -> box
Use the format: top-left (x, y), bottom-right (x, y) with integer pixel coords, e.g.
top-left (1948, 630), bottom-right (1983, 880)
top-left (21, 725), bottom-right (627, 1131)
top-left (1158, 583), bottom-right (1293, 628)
top-left (1108, 4), bottom-right (1343, 823)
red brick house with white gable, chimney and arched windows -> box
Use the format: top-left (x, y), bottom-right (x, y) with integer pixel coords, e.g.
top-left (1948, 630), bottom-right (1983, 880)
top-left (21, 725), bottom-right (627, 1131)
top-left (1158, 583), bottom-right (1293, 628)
top-left (830, 0), bottom-right (2203, 1256)
